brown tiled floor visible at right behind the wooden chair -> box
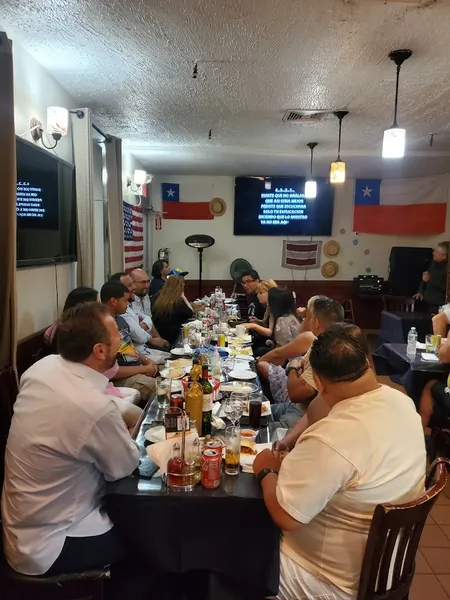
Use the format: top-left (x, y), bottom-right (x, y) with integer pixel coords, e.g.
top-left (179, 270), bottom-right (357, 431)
top-left (378, 376), bottom-right (450, 600)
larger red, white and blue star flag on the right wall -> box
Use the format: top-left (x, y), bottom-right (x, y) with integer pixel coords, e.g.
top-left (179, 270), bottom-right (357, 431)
top-left (353, 175), bottom-right (448, 235)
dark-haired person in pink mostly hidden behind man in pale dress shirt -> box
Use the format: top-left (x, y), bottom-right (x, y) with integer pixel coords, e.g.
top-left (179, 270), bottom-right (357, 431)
top-left (44, 286), bottom-right (142, 431)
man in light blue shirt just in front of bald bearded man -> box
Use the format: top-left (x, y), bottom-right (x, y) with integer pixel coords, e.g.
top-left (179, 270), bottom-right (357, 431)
top-left (111, 273), bottom-right (170, 364)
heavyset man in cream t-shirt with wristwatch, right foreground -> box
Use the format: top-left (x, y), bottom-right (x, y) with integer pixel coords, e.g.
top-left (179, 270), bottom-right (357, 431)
top-left (254, 331), bottom-right (426, 600)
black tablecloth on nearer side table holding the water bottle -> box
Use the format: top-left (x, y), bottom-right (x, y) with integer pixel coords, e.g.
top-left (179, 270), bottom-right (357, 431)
top-left (372, 344), bottom-right (450, 407)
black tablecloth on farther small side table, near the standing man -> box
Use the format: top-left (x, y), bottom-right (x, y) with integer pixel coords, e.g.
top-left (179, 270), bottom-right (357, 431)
top-left (377, 310), bottom-right (433, 346)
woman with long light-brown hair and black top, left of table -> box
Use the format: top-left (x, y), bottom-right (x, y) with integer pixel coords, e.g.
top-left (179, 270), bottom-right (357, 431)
top-left (152, 275), bottom-right (194, 346)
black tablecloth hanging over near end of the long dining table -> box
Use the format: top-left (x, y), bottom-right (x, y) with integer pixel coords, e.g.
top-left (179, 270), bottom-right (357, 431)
top-left (104, 356), bottom-right (280, 600)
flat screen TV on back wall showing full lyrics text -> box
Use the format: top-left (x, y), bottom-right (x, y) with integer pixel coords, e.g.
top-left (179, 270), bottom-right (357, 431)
top-left (234, 177), bottom-right (334, 236)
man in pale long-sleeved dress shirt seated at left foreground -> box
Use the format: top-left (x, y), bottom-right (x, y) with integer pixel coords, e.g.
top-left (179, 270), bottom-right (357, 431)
top-left (2, 303), bottom-right (139, 575)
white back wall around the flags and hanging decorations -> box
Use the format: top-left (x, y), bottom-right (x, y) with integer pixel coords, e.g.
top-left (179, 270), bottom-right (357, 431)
top-left (151, 175), bottom-right (450, 280)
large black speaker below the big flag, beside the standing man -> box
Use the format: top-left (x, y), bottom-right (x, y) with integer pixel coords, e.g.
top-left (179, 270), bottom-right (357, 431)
top-left (388, 246), bottom-right (433, 296)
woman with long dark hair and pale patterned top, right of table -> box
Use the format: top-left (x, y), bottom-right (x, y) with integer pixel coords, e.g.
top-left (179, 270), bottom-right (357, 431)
top-left (244, 282), bottom-right (300, 348)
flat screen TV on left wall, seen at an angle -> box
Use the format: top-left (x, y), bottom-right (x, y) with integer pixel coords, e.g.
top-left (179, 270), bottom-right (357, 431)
top-left (16, 138), bottom-right (77, 267)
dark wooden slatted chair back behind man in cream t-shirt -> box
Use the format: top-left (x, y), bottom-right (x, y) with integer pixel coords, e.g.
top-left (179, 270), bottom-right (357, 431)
top-left (357, 458), bottom-right (450, 600)
